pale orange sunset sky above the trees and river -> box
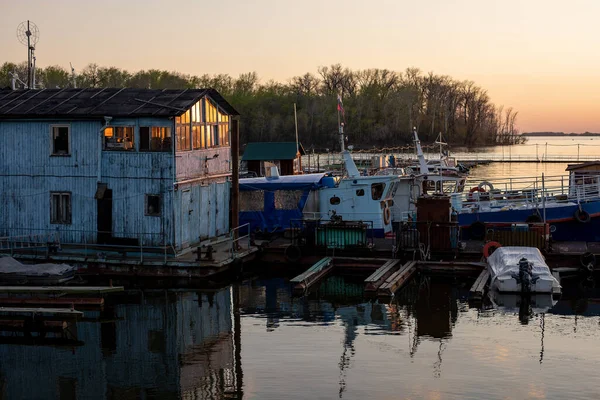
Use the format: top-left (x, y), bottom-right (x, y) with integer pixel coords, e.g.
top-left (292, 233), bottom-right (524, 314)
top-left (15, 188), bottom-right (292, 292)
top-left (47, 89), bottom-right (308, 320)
top-left (0, 0), bottom-right (600, 132)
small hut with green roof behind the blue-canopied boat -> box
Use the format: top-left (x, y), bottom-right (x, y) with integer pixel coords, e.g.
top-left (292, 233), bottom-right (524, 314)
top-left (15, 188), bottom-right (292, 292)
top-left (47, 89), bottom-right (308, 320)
top-left (242, 142), bottom-right (306, 176)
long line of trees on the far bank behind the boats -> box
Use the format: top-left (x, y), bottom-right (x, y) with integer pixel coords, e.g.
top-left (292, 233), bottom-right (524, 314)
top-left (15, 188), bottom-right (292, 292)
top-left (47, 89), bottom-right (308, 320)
top-left (0, 62), bottom-right (525, 151)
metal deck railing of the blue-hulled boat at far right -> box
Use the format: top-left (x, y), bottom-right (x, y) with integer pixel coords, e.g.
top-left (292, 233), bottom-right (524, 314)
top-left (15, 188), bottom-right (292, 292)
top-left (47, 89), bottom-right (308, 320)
top-left (453, 176), bottom-right (600, 208)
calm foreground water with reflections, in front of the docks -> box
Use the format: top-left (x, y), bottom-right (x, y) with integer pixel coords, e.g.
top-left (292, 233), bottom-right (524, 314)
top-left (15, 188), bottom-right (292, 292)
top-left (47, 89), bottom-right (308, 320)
top-left (0, 276), bottom-right (600, 400)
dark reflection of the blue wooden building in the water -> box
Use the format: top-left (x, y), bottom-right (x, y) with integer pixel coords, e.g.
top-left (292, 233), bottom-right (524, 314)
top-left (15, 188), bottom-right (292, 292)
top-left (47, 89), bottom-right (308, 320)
top-left (0, 289), bottom-right (242, 399)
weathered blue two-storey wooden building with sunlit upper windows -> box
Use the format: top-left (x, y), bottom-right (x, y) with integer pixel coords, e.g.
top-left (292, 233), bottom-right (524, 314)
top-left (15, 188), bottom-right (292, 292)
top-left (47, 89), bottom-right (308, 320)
top-left (0, 89), bottom-right (238, 251)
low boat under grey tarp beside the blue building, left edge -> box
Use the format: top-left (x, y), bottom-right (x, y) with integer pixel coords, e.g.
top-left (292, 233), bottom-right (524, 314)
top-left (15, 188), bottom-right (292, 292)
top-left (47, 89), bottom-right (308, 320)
top-left (0, 257), bottom-right (77, 285)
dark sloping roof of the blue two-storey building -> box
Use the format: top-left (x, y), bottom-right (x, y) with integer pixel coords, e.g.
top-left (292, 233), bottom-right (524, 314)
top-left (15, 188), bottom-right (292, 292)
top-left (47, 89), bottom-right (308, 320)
top-left (0, 88), bottom-right (239, 119)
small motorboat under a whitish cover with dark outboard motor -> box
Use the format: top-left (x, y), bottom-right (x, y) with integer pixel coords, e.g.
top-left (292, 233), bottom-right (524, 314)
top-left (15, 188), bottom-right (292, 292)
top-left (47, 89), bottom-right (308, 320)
top-left (487, 246), bottom-right (561, 294)
